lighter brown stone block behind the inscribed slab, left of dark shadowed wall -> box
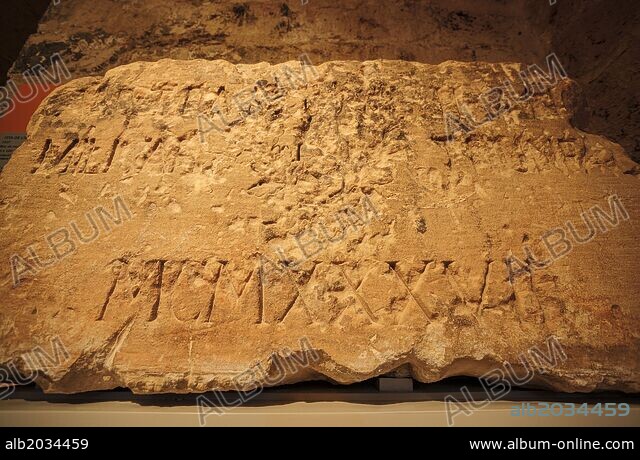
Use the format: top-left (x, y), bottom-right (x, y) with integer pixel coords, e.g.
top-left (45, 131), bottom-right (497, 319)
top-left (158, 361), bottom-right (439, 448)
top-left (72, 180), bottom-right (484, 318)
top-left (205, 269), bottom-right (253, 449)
top-left (6, 0), bottom-right (546, 78)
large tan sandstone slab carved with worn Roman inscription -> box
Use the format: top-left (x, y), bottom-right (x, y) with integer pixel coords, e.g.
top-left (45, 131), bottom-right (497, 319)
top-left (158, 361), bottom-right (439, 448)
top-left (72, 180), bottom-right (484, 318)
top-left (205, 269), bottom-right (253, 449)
top-left (0, 60), bottom-right (640, 392)
